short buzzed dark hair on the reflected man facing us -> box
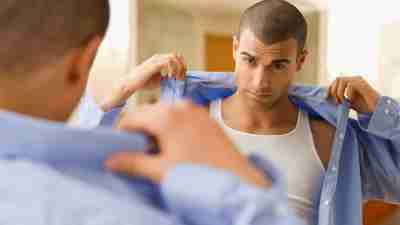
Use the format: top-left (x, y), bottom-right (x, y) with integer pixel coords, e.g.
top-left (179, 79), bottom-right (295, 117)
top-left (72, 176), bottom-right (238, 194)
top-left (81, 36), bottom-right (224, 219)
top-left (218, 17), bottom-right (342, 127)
top-left (239, 0), bottom-right (307, 52)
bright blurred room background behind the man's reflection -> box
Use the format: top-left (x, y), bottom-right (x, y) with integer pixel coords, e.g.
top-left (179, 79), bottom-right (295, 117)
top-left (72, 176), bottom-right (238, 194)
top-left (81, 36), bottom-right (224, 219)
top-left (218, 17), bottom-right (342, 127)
top-left (84, 0), bottom-right (400, 225)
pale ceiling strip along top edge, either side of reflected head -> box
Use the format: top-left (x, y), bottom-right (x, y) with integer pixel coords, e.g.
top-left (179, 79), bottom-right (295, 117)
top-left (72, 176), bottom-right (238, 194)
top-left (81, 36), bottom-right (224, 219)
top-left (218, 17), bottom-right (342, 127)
top-left (143, 0), bottom-right (328, 14)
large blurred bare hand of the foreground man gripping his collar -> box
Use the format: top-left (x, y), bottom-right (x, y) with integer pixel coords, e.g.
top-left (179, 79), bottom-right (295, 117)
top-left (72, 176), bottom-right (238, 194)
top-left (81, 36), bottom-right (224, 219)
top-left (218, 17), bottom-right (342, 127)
top-left (105, 103), bottom-right (269, 187)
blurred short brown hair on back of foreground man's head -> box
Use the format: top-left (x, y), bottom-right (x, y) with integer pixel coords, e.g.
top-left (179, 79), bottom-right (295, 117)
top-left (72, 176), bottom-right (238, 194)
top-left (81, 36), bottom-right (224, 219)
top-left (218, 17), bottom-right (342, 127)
top-left (0, 0), bottom-right (110, 76)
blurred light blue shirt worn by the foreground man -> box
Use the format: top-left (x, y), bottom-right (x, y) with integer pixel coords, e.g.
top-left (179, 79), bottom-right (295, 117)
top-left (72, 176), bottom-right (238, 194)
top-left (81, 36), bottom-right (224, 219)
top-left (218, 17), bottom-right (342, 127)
top-left (0, 98), bottom-right (299, 225)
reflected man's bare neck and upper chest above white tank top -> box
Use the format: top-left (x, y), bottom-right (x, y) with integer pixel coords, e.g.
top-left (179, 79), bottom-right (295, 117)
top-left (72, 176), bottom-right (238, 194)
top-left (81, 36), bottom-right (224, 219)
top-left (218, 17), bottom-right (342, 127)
top-left (221, 94), bottom-right (298, 134)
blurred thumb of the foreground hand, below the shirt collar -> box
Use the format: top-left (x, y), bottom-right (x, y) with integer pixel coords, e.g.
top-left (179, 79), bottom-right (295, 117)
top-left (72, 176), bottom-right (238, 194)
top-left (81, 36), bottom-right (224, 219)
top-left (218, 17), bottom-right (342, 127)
top-left (104, 152), bottom-right (165, 183)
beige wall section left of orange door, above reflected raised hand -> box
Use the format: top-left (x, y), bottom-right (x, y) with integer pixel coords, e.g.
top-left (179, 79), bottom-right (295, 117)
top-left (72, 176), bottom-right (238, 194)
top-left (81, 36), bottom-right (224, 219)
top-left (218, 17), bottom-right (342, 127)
top-left (138, 1), bottom-right (200, 68)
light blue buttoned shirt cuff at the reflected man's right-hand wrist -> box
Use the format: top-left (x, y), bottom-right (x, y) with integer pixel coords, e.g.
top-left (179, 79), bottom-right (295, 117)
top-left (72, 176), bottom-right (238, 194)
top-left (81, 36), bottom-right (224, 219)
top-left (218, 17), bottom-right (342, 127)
top-left (359, 96), bottom-right (400, 137)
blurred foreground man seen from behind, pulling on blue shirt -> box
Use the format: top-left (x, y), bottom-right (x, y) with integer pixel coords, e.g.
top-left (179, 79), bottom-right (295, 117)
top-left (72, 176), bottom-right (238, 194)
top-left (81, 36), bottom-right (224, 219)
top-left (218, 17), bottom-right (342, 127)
top-left (0, 0), bottom-right (304, 225)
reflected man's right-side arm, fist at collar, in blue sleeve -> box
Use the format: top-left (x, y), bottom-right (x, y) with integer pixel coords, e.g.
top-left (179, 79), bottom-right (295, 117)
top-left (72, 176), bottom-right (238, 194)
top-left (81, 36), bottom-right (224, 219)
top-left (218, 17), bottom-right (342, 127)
top-left (330, 77), bottom-right (400, 202)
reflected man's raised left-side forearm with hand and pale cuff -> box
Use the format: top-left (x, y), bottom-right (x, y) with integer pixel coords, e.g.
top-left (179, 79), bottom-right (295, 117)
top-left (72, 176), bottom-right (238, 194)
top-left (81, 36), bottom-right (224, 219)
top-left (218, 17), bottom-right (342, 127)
top-left (77, 53), bottom-right (186, 128)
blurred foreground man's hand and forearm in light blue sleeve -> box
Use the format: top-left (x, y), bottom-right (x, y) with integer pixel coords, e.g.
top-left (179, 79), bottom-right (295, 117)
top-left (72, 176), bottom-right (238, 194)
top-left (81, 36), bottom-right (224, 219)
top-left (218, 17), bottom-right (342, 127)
top-left (106, 103), bottom-right (299, 225)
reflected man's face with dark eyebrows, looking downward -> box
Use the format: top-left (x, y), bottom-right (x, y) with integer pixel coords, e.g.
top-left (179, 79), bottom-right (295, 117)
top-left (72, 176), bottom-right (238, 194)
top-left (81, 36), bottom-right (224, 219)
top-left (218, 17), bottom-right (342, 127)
top-left (234, 30), bottom-right (306, 108)
